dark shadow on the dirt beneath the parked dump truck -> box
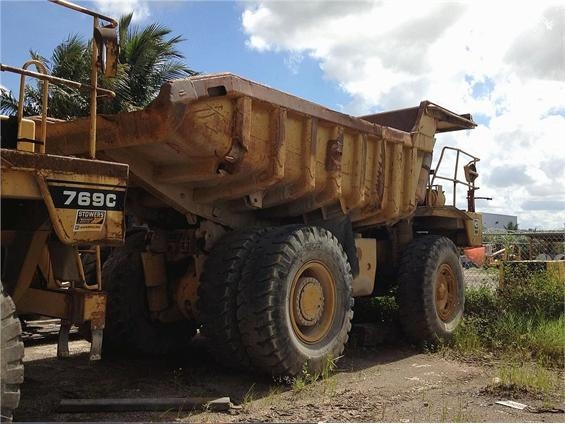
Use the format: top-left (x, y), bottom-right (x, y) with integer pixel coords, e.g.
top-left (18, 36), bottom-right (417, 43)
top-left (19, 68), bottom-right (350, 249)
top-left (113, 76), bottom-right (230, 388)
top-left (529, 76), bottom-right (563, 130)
top-left (15, 324), bottom-right (417, 422)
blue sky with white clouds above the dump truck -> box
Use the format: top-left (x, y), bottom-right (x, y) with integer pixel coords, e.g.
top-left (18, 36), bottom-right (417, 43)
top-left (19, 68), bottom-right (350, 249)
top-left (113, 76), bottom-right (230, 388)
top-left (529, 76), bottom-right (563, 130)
top-left (0, 0), bottom-right (565, 230)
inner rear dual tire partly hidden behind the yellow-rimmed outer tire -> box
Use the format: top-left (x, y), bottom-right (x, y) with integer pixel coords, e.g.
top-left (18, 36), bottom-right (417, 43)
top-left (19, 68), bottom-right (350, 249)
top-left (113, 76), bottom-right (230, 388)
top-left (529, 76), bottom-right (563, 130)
top-left (198, 228), bottom-right (268, 368)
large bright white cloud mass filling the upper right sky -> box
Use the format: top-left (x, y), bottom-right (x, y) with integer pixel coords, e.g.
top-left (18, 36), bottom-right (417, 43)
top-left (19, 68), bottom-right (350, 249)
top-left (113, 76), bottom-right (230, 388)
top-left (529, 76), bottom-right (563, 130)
top-left (242, 0), bottom-right (565, 228)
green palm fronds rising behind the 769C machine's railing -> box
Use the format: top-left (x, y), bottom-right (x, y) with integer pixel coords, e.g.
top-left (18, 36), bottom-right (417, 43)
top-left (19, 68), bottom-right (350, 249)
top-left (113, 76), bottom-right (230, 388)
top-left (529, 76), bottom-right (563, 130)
top-left (0, 14), bottom-right (197, 119)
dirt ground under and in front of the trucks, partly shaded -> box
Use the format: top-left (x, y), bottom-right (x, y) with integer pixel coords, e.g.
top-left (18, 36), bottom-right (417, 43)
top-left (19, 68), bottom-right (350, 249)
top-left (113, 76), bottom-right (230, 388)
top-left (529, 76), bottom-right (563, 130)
top-left (15, 322), bottom-right (565, 422)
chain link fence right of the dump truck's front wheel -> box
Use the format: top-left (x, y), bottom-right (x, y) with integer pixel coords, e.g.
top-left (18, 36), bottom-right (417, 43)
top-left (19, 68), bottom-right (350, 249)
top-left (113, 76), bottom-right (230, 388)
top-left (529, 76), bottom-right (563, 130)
top-left (461, 230), bottom-right (565, 288)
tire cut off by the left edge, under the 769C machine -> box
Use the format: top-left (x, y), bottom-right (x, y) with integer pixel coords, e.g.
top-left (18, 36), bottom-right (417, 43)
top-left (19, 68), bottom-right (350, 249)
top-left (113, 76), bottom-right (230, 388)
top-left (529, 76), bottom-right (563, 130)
top-left (0, 287), bottom-right (24, 421)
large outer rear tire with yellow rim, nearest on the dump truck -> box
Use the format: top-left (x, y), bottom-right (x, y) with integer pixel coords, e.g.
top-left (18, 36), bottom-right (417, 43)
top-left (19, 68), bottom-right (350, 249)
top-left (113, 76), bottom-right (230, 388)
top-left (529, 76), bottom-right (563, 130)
top-left (237, 226), bottom-right (353, 376)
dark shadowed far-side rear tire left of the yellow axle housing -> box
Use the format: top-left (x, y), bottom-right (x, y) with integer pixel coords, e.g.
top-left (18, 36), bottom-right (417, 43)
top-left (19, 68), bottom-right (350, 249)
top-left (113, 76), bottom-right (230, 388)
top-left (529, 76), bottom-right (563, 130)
top-left (102, 232), bottom-right (196, 355)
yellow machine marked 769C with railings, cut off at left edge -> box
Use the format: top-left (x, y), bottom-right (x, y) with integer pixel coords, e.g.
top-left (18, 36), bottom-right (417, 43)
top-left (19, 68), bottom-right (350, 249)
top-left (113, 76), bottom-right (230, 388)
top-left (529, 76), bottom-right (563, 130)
top-left (0, 0), bottom-right (129, 420)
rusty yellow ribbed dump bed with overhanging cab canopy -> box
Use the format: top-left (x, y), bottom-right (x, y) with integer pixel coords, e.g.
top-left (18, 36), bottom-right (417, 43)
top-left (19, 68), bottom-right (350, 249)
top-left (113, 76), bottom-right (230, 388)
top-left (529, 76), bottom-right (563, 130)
top-left (48, 74), bottom-right (475, 227)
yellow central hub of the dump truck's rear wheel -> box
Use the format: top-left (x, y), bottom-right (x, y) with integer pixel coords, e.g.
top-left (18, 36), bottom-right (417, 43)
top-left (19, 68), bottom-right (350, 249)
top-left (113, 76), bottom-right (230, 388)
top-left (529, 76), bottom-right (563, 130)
top-left (294, 277), bottom-right (324, 327)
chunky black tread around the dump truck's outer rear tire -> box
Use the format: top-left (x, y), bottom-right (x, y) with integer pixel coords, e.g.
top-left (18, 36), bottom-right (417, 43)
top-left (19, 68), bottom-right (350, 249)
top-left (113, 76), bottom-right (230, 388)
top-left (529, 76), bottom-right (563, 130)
top-left (238, 226), bottom-right (353, 376)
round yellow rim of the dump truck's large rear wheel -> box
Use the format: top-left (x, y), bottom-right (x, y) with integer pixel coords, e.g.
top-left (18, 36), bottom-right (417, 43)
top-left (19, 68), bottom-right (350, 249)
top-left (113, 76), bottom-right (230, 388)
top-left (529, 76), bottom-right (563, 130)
top-left (288, 260), bottom-right (336, 344)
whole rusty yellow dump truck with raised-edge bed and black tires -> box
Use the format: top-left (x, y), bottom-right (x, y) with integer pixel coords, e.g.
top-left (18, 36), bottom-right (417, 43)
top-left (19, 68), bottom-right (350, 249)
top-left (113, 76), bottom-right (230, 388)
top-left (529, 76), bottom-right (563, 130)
top-left (41, 73), bottom-right (482, 376)
